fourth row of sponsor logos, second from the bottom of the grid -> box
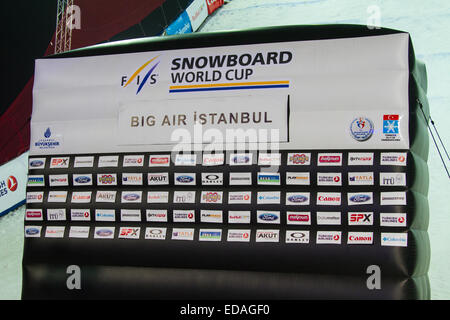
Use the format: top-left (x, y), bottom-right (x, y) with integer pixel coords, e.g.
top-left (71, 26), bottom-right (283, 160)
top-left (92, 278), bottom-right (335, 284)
top-left (25, 208), bottom-right (407, 227)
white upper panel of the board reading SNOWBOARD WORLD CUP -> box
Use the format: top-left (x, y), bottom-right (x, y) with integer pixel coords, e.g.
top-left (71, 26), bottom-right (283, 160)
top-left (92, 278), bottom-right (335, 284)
top-left (30, 33), bottom-right (409, 155)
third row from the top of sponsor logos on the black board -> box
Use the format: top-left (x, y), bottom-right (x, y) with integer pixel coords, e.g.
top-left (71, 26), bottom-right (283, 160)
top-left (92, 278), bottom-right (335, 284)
top-left (26, 190), bottom-right (406, 206)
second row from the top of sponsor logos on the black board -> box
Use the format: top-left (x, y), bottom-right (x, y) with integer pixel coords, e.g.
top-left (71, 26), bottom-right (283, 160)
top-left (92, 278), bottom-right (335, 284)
top-left (27, 172), bottom-right (406, 187)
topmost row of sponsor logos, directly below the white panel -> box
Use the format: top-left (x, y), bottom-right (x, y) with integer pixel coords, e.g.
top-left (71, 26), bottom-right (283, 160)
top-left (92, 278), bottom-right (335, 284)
top-left (28, 152), bottom-right (407, 169)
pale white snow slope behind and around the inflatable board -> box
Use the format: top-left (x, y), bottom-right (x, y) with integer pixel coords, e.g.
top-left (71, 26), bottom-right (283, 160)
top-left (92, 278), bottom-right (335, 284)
top-left (0, 0), bottom-right (450, 299)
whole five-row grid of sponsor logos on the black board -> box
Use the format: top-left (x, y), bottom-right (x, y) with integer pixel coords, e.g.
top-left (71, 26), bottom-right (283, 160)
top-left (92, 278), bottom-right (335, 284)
top-left (25, 151), bottom-right (407, 246)
